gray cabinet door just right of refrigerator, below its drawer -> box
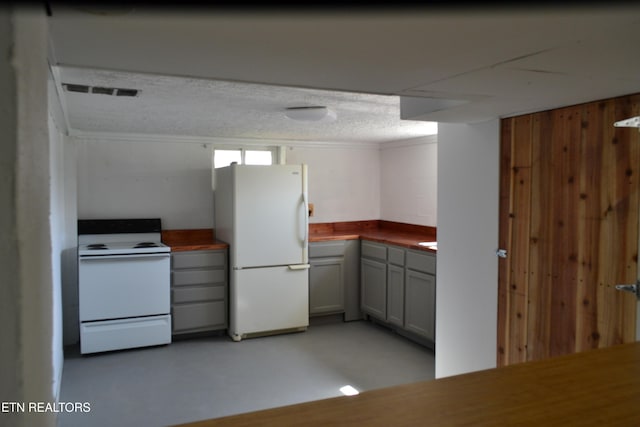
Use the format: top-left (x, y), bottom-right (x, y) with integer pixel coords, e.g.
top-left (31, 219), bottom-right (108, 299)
top-left (309, 257), bottom-right (344, 314)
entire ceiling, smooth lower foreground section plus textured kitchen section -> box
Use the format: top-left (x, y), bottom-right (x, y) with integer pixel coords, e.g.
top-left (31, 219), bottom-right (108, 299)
top-left (49, 1), bottom-right (640, 141)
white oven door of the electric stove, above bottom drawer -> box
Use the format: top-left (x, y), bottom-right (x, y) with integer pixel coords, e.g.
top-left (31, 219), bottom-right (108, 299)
top-left (78, 253), bottom-right (171, 322)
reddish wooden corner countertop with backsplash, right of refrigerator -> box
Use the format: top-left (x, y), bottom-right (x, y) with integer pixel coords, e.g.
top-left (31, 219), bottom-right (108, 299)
top-left (309, 220), bottom-right (437, 253)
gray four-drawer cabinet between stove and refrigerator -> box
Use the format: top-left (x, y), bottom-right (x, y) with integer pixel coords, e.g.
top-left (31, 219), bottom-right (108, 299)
top-left (171, 249), bottom-right (228, 335)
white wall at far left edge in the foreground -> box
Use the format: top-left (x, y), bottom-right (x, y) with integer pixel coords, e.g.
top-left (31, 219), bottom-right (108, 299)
top-left (0, 6), bottom-right (62, 426)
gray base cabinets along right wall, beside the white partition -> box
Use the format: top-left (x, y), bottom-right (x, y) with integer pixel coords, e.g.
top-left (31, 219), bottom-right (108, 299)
top-left (361, 240), bottom-right (436, 345)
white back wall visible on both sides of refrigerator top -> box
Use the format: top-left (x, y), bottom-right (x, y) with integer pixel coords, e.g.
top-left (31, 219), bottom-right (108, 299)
top-left (77, 139), bottom-right (380, 229)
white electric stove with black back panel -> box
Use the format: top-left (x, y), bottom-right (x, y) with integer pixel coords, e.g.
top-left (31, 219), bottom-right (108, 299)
top-left (78, 219), bottom-right (171, 354)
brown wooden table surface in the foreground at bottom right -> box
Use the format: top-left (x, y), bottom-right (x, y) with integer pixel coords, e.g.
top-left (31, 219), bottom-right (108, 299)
top-left (175, 343), bottom-right (640, 427)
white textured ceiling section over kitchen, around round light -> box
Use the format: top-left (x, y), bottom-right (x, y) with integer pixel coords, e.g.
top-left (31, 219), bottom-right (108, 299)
top-left (57, 67), bottom-right (437, 143)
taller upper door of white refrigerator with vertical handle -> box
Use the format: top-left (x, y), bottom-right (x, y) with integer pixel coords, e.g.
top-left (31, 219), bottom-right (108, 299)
top-left (230, 165), bottom-right (308, 268)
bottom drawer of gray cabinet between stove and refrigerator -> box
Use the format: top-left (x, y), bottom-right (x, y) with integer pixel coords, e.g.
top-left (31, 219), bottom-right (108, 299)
top-left (171, 301), bottom-right (227, 332)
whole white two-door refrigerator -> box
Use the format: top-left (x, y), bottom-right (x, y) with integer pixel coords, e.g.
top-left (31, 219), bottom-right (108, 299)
top-left (214, 164), bottom-right (309, 341)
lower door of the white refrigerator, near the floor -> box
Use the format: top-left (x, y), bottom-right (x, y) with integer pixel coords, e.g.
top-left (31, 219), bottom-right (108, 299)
top-left (229, 265), bottom-right (309, 341)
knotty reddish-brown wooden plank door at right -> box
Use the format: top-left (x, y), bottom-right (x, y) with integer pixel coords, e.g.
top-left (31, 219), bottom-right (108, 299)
top-left (498, 95), bottom-right (640, 366)
